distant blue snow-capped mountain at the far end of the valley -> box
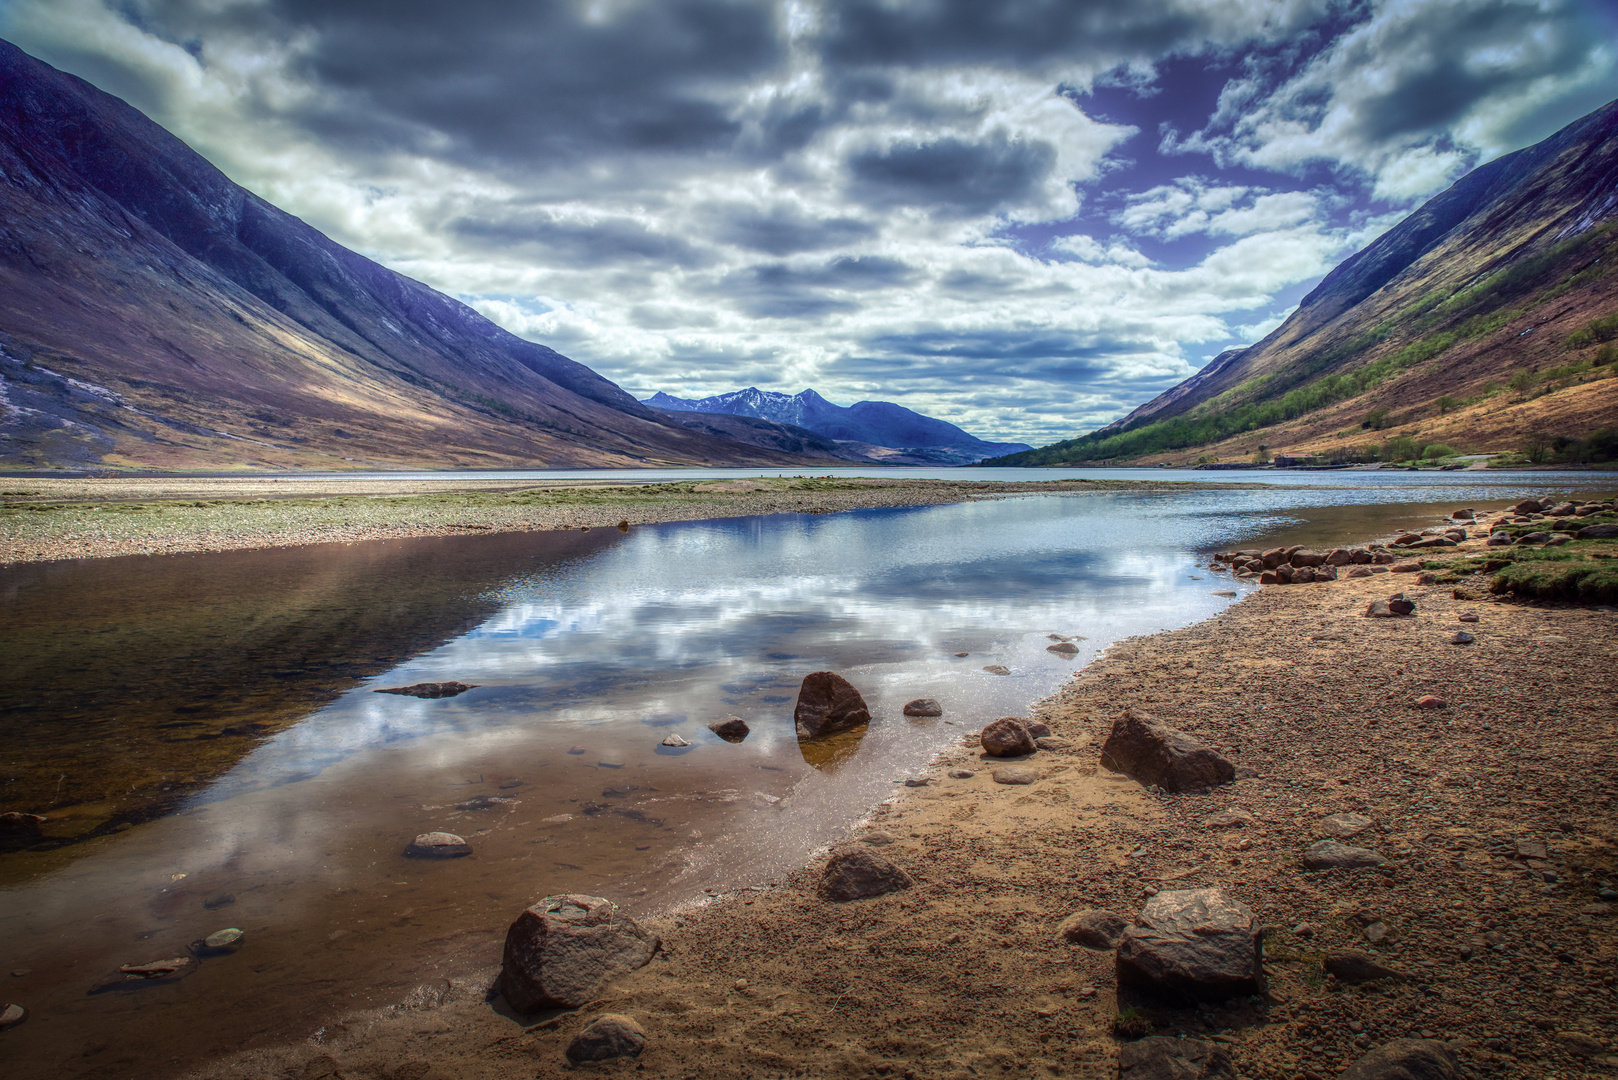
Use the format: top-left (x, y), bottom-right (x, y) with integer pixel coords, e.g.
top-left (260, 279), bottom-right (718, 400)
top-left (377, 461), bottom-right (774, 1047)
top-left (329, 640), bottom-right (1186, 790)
top-left (646, 387), bottom-right (1032, 463)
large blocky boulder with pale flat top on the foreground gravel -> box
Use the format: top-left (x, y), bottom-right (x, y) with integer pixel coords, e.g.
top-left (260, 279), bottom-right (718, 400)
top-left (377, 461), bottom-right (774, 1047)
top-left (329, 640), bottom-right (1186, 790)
top-left (1116, 889), bottom-right (1264, 1001)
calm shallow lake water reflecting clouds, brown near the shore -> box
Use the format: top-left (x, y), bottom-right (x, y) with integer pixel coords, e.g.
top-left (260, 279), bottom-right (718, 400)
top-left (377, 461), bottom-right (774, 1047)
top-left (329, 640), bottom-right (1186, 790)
top-left (0, 470), bottom-right (1618, 1077)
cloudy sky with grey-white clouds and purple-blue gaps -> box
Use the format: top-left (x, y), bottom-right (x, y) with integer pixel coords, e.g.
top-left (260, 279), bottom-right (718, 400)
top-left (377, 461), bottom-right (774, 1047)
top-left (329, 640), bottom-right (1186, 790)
top-left (0, 0), bottom-right (1618, 445)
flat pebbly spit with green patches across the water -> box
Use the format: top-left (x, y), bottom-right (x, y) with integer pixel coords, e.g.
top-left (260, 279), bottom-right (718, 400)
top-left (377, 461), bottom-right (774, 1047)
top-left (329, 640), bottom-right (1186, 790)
top-left (0, 476), bottom-right (1262, 567)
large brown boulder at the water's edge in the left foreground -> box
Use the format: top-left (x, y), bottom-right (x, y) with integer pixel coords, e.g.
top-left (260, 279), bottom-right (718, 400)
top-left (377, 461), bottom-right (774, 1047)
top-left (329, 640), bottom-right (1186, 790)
top-left (495, 894), bottom-right (659, 1012)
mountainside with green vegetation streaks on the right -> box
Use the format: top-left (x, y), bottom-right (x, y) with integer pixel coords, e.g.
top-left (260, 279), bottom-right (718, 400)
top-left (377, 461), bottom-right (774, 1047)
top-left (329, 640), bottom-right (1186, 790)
top-left (993, 102), bottom-right (1618, 465)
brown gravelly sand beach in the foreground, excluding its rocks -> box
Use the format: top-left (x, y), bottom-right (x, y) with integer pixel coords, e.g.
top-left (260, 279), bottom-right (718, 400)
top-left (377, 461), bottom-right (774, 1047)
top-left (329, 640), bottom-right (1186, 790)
top-left (180, 501), bottom-right (1618, 1080)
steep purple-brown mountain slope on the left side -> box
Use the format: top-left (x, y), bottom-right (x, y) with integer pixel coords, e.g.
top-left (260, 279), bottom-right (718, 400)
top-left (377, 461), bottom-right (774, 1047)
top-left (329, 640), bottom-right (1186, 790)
top-left (0, 42), bottom-right (825, 468)
